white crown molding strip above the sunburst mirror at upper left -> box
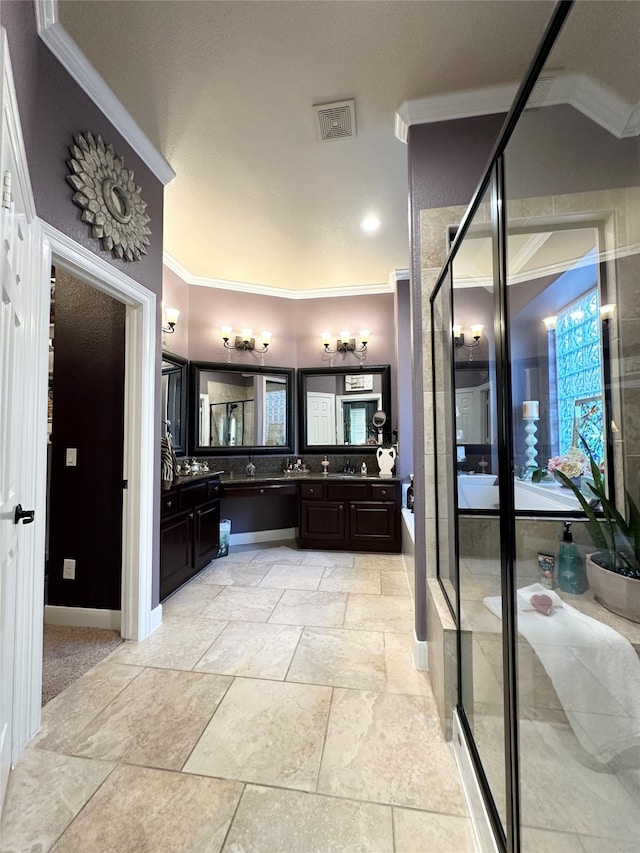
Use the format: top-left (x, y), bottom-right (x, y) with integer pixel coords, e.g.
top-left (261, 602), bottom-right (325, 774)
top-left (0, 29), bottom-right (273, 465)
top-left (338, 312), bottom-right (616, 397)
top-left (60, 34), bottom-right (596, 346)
top-left (34, 0), bottom-right (176, 186)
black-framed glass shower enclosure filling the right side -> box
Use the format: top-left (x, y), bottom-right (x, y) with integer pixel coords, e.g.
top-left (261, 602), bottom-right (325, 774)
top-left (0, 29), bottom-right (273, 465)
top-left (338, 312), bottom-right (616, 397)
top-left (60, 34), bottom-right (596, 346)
top-left (430, 2), bottom-right (640, 853)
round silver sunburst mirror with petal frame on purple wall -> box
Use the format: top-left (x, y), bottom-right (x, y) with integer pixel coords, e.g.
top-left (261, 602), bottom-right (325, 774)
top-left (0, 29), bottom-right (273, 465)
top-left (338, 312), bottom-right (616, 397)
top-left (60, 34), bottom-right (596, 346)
top-left (67, 133), bottom-right (151, 261)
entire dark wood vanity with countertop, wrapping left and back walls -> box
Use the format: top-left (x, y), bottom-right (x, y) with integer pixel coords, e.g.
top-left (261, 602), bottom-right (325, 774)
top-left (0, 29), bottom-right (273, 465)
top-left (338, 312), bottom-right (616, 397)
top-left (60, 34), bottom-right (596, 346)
top-left (160, 472), bottom-right (402, 601)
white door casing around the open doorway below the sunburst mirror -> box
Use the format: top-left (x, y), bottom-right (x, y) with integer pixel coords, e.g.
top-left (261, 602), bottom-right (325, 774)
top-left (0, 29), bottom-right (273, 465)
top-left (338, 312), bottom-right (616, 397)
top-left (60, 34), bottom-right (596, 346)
top-left (39, 220), bottom-right (162, 641)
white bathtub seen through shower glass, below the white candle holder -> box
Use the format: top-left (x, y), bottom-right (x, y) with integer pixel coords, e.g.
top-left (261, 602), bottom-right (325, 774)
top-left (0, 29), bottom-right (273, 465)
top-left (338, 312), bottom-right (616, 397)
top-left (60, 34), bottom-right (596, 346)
top-left (457, 474), bottom-right (580, 512)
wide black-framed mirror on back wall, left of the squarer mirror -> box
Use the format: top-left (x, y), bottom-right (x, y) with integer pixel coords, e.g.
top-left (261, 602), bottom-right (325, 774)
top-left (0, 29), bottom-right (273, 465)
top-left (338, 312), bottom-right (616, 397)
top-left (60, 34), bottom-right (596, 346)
top-left (189, 361), bottom-right (294, 456)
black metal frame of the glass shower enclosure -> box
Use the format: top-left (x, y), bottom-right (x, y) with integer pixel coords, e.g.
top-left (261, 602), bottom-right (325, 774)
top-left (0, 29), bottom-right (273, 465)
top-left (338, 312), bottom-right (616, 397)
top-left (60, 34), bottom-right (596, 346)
top-left (429, 0), bottom-right (574, 853)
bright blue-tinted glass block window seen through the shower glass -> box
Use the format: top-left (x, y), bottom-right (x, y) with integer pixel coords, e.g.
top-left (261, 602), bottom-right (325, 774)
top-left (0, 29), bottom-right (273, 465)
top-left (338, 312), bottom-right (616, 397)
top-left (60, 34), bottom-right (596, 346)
top-left (556, 287), bottom-right (604, 462)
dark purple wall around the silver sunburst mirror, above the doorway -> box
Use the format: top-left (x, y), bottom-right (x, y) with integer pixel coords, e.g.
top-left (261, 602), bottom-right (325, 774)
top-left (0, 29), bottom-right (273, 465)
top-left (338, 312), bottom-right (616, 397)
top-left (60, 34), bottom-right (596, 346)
top-left (0, 0), bottom-right (163, 607)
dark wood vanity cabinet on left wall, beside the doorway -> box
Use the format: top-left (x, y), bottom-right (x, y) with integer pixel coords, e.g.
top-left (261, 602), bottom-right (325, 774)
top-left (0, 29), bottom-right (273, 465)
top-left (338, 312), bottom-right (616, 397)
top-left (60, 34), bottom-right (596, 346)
top-left (160, 478), bottom-right (222, 601)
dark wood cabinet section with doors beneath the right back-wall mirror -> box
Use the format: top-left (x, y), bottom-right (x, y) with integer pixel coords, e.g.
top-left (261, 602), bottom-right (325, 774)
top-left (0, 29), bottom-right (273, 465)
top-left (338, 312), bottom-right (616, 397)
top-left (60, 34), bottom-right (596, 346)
top-left (299, 480), bottom-right (401, 552)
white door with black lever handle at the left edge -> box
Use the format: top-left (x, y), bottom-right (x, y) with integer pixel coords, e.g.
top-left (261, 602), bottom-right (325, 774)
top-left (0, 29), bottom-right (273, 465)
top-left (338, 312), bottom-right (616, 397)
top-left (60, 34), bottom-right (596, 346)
top-left (0, 30), bottom-right (46, 805)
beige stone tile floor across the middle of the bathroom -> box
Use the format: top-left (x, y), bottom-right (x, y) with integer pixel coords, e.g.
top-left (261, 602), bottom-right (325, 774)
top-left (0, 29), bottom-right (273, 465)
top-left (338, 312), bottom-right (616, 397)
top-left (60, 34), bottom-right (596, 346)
top-left (0, 544), bottom-right (475, 853)
